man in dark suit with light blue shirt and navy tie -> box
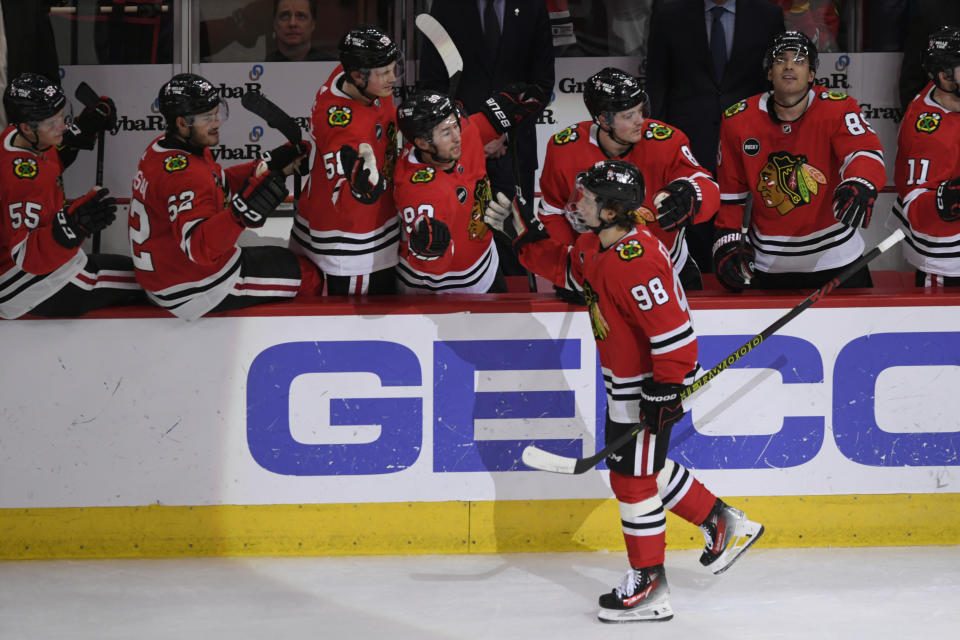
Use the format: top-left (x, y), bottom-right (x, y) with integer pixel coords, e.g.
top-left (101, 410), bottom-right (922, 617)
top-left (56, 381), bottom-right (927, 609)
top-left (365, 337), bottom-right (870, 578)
top-left (647, 0), bottom-right (784, 271)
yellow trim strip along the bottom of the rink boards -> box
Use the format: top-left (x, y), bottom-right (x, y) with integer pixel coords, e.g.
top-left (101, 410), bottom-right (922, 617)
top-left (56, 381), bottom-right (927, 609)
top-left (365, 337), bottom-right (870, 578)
top-left (0, 494), bottom-right (960, 560)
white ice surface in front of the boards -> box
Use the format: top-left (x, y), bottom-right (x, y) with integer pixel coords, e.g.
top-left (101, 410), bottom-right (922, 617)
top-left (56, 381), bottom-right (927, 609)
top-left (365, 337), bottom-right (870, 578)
top-left (0, 547), bottom-right (960, 640)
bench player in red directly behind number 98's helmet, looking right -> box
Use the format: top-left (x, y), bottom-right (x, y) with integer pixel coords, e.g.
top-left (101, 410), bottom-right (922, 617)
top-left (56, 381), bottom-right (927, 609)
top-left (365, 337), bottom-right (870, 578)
top-left (540, 67), bottom-right (720, 290)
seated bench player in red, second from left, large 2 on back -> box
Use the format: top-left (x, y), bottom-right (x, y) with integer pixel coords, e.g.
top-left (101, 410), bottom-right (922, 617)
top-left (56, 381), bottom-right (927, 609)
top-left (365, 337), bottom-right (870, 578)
top-left (129, 73), bottom-right (323, 320)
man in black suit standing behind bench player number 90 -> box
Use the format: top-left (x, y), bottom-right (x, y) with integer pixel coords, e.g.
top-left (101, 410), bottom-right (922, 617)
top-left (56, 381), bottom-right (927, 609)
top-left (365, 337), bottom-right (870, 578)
top-left (418, 0), bottom-right (554, 275)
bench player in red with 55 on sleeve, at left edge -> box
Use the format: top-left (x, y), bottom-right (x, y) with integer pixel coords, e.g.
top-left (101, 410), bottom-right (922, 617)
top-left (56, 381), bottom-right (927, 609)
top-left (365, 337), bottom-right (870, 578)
top-left (0, 73), bottom-right (143, 318)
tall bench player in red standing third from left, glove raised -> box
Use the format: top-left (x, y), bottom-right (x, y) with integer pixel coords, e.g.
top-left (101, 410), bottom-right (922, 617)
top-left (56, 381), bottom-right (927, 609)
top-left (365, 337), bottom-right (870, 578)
top-left (291, 25), bottom-right (402, 295)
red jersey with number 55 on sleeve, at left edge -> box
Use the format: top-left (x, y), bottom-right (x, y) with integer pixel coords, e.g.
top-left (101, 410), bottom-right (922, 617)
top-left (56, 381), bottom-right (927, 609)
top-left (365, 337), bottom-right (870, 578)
top-left (0, 126), bottom-right (87, 319)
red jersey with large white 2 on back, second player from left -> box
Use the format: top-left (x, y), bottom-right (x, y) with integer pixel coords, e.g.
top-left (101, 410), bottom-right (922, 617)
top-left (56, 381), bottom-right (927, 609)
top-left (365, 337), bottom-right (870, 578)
top-left (128, 137), bottom-right (254, 320)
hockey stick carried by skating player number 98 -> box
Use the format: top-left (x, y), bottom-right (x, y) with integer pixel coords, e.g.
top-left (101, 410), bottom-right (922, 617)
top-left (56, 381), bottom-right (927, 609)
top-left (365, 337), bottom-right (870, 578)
top-left (523, 229), bottom-right (903, 474)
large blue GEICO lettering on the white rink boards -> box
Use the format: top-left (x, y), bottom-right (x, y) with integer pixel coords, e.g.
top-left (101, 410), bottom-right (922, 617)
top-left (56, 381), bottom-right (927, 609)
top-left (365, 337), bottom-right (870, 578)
top-left (246, 332), bottom-right (960, 476)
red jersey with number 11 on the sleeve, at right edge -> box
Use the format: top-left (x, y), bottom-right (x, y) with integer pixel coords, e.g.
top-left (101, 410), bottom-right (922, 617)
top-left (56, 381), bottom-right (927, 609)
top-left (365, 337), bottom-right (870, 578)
top-left (893, 83), bottom-right (960, 276)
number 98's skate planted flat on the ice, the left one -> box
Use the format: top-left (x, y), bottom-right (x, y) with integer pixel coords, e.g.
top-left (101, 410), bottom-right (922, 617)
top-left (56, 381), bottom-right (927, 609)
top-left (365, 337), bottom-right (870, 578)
top-left (597, 564), bottom-right (673, 622)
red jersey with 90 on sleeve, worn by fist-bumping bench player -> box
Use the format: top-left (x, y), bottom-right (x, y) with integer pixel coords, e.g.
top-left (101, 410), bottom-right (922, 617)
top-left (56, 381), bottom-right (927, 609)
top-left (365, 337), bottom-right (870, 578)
top-left (393, 114), bottom-right (500, 293)
